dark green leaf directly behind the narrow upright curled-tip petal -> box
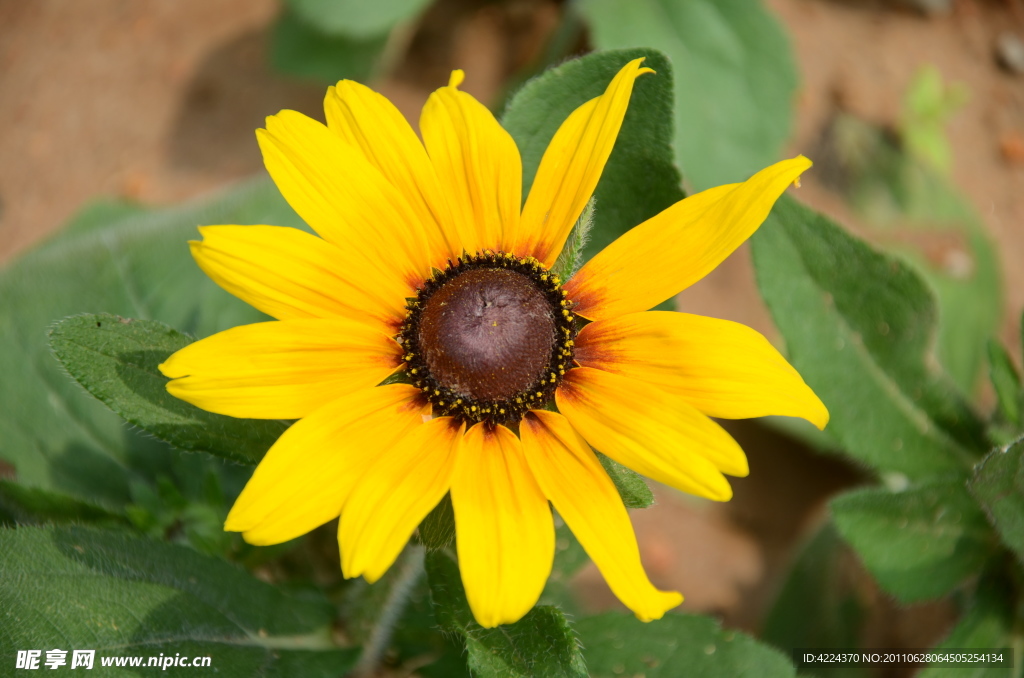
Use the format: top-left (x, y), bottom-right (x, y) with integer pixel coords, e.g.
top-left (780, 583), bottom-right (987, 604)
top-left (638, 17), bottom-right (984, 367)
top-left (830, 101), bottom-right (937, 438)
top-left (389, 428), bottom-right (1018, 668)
top-left (502, 49), bottom-right (683, 266)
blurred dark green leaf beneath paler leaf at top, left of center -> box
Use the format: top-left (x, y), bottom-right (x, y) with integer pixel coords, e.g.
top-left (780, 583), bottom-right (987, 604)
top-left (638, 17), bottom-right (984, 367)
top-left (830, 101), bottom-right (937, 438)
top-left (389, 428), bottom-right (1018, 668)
top-left (270, 8), bottom-right (388, 85)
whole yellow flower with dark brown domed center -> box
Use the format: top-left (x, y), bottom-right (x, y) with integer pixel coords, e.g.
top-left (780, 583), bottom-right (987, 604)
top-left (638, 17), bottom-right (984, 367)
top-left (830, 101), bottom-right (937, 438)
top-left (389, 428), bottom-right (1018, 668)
top-left (161, 59), bottom-right (828, 627)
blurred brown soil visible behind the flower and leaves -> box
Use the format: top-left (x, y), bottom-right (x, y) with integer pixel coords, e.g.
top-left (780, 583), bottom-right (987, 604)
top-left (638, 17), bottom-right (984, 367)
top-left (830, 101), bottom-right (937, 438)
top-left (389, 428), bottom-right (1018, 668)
top-left (0, 0), bottom-right (1024, 663)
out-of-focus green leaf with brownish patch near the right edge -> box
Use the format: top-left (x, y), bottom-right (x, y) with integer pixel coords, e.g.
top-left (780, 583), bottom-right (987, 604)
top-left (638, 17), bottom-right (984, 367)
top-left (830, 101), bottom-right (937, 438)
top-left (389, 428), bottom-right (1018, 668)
top-left (820, 114), bottom-right (1002, 393)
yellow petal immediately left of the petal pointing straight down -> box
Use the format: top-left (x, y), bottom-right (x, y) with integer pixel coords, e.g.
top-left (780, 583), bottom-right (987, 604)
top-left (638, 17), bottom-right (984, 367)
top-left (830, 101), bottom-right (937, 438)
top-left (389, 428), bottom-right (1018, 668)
top-left (338, 417), bottom-right (465, 584)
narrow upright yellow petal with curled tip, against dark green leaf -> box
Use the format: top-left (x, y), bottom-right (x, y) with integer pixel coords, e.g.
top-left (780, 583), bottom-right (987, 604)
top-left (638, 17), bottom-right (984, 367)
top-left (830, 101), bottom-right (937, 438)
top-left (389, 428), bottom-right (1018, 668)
top-left (520, 58), bottom-right (653, 266)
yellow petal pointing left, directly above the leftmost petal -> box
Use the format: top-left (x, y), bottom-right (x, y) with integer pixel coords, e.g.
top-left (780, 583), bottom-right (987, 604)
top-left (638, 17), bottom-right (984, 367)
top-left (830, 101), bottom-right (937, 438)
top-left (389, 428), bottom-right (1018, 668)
top-left (189, 226), bottom-right (406, 333)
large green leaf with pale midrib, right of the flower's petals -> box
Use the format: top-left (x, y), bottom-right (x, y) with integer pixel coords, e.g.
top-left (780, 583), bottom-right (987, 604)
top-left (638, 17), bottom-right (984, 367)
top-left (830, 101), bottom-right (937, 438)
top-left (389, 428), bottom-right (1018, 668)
top-left (751, 196), bottom-right (988, 478)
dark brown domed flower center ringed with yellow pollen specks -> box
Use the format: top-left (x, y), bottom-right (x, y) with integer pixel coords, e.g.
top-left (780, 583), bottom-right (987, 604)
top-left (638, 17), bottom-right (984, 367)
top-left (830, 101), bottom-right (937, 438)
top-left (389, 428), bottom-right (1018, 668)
top-left (399, 253), bottom-right (575, 423)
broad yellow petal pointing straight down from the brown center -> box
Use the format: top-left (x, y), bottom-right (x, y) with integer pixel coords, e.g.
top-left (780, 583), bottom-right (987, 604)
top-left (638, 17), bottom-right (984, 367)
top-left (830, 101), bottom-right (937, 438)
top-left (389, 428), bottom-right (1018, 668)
top-left (452, 423), bottom-right (555, 629)
